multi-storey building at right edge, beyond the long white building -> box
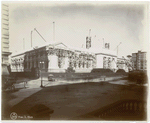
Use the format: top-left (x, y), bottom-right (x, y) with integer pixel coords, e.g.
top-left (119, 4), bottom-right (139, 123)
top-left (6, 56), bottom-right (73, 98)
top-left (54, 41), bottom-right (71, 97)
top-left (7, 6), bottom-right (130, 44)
top-left (132, 51), bottom-right (147, 70)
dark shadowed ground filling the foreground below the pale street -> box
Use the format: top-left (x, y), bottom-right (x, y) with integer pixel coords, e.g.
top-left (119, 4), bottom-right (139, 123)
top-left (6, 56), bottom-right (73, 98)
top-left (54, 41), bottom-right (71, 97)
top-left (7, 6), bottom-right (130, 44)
top-left (2, 79), bottom-right (147, 120)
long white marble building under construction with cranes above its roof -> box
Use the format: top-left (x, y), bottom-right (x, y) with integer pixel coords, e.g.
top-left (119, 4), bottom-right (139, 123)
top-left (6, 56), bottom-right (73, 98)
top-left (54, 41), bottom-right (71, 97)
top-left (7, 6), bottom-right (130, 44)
top-left (11, 39), bottom-right (127, 73)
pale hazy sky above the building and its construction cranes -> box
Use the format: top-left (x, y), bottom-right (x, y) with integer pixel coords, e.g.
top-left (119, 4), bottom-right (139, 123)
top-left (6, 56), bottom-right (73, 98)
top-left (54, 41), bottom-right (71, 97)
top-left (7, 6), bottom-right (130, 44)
top-left (9, 2), bottom-right (148, 56)
